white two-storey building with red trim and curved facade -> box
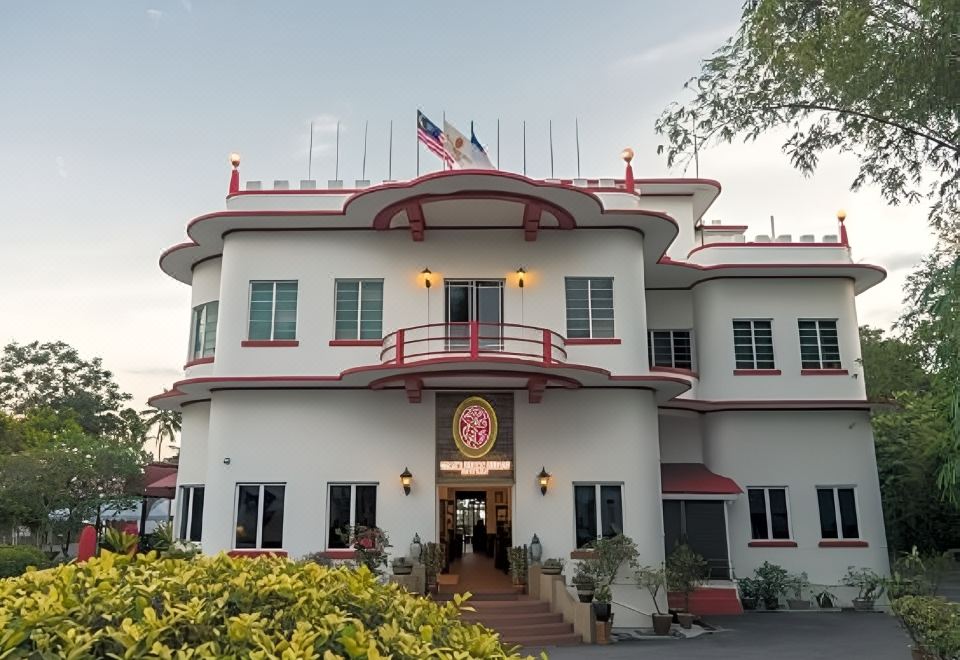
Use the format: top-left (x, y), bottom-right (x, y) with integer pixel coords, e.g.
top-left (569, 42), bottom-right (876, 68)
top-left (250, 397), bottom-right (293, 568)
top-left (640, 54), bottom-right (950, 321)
top-left (152, 156), bottom-right (887, 622)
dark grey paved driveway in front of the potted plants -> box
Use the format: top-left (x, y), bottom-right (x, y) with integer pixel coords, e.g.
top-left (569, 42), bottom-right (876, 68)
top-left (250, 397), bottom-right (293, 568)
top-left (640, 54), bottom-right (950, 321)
top-left (547, 612), bottom-right (910, 660)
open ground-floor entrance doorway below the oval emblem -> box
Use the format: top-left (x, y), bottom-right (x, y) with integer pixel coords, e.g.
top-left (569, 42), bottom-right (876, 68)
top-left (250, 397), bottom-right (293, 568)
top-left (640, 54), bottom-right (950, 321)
top-left (438, 484), bottom-right (513, 593)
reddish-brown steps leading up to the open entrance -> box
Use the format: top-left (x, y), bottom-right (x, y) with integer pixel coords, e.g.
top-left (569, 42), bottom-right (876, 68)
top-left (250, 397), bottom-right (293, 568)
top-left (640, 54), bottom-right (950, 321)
top-left (462, 594), bottom-right (583, 647)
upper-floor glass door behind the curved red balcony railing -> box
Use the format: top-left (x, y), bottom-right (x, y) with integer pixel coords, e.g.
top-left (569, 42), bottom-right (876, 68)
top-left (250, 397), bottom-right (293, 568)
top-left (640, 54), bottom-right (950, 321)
top-left (444, 280), bottom-right (503, 351)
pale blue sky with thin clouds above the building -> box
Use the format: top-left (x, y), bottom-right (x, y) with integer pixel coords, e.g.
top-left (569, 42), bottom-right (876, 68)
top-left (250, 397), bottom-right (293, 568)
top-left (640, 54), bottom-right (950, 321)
top-left (0, 0), bottom-right (933, 408)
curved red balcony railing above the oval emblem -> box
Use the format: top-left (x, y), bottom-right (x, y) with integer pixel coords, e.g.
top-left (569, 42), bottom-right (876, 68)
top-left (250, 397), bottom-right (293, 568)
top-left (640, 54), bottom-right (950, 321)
top-left (380, 321), bottom-right (567, 365)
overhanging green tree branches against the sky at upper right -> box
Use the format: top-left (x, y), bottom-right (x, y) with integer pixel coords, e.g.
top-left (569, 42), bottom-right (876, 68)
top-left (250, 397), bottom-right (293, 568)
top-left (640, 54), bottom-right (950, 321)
top-left (656, 0), bottom-right (960, 234)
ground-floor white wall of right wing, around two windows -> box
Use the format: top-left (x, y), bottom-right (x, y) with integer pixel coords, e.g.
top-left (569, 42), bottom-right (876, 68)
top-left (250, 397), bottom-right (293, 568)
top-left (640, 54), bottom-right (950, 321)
top-left (704, 411), bottom-right (888, 598)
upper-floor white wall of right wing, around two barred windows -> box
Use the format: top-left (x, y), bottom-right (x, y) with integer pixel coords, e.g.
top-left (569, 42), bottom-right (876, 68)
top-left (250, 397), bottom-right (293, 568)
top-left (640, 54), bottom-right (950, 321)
top-left (693, 278), bottom-right (866, 400)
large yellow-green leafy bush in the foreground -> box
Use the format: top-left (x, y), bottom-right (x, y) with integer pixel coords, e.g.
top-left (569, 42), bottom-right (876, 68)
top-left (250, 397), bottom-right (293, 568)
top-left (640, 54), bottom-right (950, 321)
top-left (0, 553), bottom-right (532, 660)
